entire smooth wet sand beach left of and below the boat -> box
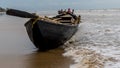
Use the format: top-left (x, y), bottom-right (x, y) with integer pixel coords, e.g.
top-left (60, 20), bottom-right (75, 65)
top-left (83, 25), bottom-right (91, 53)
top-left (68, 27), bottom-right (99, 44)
top-left (0, 16), bottom-right (72, 68)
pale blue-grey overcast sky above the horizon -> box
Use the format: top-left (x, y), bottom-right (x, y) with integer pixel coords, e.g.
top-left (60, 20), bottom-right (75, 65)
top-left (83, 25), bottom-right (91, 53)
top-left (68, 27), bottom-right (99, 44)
top-left (0, 0), bottom-right (120, 10)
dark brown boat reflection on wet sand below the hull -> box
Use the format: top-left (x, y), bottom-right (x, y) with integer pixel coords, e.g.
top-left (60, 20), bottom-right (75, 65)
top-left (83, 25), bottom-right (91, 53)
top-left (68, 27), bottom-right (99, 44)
top-left (27, 49), bottom-right (72, 68)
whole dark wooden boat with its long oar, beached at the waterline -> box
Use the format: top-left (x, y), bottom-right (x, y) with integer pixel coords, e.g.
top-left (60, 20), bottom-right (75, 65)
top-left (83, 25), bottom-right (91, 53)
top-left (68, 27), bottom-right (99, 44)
top-left (7, 10), bottom-right (80, 50)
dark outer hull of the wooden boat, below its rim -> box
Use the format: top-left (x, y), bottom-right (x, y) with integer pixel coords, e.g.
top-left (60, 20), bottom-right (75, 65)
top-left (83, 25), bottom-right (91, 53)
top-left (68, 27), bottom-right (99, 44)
top-left (25, 19), bottom-right (78, 50)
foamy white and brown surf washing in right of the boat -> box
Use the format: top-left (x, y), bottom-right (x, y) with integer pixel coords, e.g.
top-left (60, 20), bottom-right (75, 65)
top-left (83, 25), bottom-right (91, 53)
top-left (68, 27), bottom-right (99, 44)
top-left (63, 9), bottom-right (120, 68)
